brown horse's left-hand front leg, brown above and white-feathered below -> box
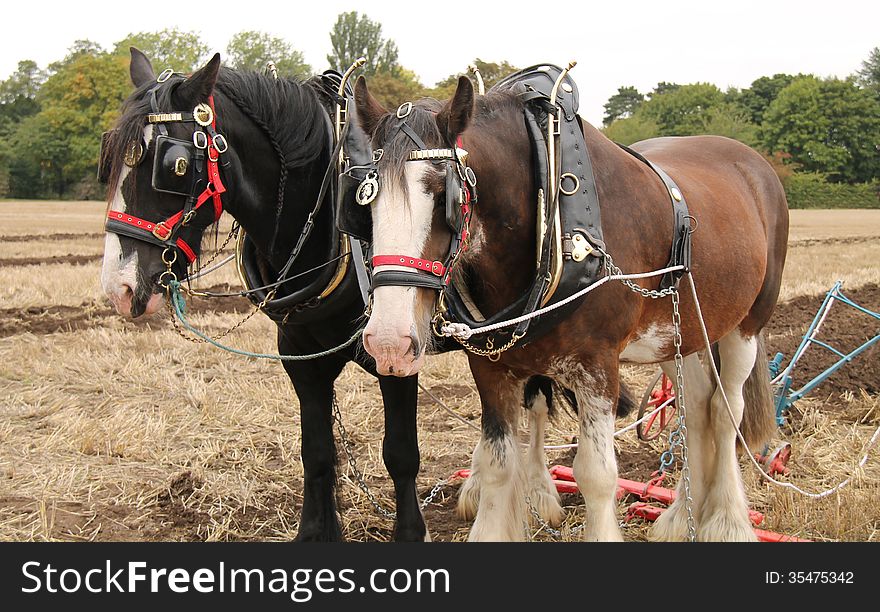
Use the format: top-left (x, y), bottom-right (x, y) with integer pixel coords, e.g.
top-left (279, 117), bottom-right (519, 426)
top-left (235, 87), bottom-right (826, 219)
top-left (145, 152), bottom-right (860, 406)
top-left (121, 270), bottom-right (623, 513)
top-left (468, 357), bottom-right (525, 541)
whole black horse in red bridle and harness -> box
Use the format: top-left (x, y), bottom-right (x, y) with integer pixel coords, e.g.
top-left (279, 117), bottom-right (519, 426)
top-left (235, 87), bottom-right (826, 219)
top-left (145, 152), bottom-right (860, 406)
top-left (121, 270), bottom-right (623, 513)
top-left (102, 48), bottom-right (428, 541)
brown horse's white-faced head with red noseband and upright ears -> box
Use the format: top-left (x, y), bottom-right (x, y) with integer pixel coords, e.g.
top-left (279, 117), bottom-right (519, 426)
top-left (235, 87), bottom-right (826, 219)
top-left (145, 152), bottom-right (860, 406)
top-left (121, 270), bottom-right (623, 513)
top-left (355, 77), bottom-right (476, 376)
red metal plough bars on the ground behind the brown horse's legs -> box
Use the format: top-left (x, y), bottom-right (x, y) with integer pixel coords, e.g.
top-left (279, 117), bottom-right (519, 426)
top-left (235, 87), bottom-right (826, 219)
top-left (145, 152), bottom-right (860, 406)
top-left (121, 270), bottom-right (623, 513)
top-left (452, 465), bottom-right (810, 542)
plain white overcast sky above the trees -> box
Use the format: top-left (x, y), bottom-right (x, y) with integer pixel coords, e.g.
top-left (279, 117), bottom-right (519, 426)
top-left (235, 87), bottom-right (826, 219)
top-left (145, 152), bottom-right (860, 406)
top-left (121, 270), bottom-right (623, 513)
top-left (0, 0), bottom-right (880, 124)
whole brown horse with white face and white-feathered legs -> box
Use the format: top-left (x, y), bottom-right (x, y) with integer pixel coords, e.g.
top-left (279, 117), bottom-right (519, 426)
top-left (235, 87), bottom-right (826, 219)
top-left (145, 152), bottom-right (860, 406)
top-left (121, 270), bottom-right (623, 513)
top-left (355, 77), bottom-right (788, 540)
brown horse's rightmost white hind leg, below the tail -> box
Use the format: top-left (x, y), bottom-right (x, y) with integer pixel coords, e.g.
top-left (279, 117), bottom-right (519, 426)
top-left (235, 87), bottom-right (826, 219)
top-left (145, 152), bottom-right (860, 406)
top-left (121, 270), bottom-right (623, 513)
top-left (697, 330), bottom-right (758, 542)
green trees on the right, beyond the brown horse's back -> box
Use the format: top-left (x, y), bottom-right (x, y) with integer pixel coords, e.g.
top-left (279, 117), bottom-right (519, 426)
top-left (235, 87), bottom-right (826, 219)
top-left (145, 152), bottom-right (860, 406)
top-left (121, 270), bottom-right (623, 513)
top-left (603, 47), bottom-right (880, 207)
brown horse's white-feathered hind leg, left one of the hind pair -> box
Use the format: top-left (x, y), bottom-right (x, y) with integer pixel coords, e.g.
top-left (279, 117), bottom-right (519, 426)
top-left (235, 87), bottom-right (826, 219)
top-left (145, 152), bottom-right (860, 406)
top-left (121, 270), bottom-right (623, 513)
top-left (650, 354), bottom-right (715, 542)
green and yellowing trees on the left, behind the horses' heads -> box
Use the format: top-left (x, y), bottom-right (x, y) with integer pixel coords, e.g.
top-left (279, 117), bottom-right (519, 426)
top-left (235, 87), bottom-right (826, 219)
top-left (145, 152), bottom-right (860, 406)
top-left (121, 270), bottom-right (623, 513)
top-left (0, 11), bottom-right (514, 199)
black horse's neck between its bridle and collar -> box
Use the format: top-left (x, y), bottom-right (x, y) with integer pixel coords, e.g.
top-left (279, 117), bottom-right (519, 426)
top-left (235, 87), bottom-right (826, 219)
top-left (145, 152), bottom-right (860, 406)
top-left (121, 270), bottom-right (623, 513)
top-left (218, 88), bottom-right (332, 269)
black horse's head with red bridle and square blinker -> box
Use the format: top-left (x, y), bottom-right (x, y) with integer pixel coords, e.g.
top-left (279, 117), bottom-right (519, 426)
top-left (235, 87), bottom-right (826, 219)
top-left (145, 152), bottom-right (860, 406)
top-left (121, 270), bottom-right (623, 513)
top-left (99, 48), bottom-right (226, 317)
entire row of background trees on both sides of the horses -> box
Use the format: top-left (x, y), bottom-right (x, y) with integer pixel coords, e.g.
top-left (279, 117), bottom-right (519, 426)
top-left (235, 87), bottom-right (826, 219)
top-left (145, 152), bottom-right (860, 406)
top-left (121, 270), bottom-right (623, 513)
top-left (0, 11), bottom-right (880, 201)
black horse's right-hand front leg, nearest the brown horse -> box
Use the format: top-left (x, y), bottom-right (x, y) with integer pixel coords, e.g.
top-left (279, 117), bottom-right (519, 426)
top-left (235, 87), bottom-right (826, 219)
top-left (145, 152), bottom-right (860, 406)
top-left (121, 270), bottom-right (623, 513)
top-left (379, 376), bottom-right (431, 542)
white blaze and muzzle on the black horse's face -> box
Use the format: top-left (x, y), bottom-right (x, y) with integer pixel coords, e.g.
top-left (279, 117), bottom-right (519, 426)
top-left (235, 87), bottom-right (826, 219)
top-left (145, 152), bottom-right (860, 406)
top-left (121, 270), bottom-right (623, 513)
top-left (101, 125), bottom-right (153, 315)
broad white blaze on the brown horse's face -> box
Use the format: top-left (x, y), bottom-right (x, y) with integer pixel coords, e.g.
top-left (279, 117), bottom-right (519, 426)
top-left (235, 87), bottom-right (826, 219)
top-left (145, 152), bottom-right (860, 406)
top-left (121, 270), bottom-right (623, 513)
top-left (364, 162), bottom-right (434, 376)
